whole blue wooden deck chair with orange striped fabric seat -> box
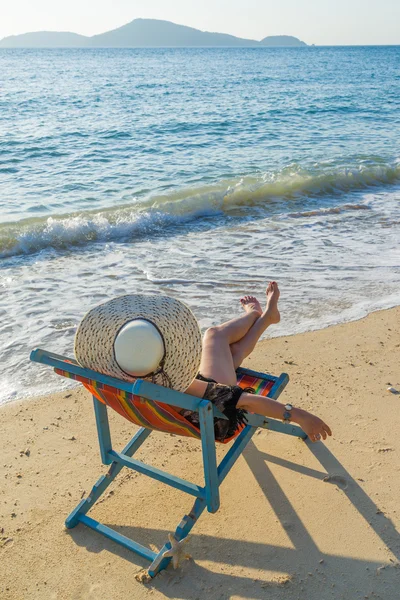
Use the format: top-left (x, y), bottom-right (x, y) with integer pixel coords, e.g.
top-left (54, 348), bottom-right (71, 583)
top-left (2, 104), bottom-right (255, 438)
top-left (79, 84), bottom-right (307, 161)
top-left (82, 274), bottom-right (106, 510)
top-left (30, 349), bottom-right (307, 577)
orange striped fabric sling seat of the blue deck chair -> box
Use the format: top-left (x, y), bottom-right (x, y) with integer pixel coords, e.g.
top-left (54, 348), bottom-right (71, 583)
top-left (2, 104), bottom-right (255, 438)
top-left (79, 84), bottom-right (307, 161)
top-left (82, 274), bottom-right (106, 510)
top-left (54, 369), bottom-right (274, 444)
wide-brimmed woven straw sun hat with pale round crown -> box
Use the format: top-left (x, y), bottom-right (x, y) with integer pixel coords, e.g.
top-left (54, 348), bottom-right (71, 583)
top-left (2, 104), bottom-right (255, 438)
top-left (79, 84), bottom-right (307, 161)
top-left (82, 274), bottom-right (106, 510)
top-left (75, 295), bottom-right (201, 392)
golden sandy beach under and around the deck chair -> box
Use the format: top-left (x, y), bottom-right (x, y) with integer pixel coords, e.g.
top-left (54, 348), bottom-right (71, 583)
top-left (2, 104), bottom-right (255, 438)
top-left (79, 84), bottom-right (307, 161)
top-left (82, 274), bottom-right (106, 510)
top-left (0, 307), bottom-right (400, 600)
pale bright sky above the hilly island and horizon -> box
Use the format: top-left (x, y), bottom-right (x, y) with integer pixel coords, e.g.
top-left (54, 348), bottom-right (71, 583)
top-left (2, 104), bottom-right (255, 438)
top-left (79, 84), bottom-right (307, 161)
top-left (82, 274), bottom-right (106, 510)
top-left (0, 0), bottom-right (400, 45)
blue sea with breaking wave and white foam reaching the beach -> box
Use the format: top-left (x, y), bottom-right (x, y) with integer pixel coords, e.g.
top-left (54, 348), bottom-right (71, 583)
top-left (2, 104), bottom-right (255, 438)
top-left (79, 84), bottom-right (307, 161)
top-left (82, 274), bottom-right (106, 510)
top-left (0, 46), bottom-right (400, 402)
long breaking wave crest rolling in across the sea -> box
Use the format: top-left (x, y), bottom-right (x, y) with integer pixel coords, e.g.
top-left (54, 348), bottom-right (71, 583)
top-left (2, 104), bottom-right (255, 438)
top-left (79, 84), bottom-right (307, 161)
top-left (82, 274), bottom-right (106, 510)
top-left (0, 161), bottom-right (400, 258)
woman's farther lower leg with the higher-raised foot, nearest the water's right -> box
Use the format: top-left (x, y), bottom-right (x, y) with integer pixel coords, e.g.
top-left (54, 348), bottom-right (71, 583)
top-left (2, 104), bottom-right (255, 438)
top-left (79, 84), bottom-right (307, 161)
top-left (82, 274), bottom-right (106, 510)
top-left (231, 281), bottom-right (280, 369)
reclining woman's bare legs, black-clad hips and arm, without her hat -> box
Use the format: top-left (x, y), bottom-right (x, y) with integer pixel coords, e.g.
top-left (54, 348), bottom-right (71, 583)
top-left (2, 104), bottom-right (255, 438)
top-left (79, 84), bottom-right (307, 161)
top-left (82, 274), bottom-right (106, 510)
top-left (182, 281), bottom-right (332, 442)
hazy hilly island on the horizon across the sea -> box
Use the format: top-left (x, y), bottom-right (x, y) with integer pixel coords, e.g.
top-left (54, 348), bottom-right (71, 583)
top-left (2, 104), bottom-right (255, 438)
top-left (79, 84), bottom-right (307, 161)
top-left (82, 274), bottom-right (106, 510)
top-left (0, 19), bottom-right (307, 48)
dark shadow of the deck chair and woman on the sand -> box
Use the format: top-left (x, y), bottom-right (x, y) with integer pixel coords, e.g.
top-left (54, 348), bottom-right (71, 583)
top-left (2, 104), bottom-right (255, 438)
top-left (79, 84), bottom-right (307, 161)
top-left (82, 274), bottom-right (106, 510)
top-left (69, 441), bottom-right (400, 600)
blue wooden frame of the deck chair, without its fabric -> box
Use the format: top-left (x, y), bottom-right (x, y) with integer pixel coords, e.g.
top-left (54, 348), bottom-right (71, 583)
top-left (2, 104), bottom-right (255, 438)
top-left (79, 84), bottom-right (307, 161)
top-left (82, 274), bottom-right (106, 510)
top-left (30, 349), bottom-right (307, 577)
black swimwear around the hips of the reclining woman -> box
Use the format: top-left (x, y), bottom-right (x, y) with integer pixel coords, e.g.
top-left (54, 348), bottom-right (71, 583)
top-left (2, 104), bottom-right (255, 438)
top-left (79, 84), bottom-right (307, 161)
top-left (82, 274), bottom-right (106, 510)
top-left (181, 373), bottom-right (254, 442)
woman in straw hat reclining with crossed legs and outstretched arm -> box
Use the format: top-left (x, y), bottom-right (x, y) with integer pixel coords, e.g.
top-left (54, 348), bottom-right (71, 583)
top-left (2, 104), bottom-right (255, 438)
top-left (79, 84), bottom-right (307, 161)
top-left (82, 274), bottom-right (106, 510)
top-left (75, 282), bottom-right (331, 442)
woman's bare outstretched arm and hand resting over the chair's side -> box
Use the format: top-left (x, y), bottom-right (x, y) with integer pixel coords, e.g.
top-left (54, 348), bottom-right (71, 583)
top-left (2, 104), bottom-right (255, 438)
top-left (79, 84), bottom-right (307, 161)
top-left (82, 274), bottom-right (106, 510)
top-left (237, 392), bottom-right (332, 442)
